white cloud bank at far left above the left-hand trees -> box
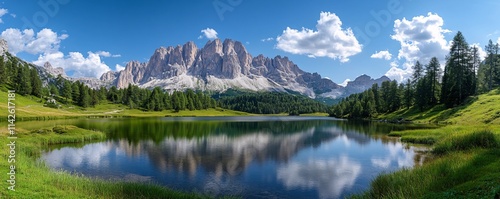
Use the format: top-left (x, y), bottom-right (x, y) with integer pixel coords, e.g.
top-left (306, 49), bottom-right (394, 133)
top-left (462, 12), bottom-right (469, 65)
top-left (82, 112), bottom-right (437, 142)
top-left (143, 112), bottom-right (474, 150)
top-left (0, 28), bottom-right (112, 78)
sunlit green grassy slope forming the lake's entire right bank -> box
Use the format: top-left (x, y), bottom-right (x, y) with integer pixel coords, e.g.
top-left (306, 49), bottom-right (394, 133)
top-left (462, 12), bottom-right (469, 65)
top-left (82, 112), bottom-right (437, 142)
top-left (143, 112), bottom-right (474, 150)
top-left (351, 89), bottom-right (500, 199)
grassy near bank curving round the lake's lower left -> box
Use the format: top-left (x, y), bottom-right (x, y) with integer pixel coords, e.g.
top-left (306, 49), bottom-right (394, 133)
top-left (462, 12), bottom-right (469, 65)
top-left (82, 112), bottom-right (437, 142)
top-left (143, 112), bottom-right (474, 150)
top-left (0, 126), bottom-right (208, 198)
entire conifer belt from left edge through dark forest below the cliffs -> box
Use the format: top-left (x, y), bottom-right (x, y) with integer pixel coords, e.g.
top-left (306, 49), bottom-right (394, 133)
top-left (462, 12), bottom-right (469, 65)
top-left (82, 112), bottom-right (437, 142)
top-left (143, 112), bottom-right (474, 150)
top-left (0, 53), bottom-right (328, 115)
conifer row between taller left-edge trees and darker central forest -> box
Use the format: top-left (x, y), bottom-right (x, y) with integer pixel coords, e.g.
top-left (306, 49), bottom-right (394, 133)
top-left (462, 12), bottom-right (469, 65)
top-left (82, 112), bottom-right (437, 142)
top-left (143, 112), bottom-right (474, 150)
top-left (51, 76), bottom-right (217, 111)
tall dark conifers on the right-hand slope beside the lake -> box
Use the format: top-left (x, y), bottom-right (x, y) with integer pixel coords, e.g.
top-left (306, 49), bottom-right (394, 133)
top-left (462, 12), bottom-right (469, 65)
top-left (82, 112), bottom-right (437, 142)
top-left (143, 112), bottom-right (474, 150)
top-left (329, 32), bottom-right (500, 118)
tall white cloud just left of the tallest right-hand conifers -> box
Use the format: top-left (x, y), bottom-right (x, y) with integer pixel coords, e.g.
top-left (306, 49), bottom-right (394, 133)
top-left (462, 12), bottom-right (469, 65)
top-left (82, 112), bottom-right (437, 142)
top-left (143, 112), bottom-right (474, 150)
top-left (386, 13), bottom-right (451, 81)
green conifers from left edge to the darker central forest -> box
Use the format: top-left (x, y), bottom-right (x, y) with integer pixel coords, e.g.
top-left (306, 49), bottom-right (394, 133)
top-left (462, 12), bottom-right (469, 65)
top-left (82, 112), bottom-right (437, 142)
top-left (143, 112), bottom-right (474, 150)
top-left (0, 53), bottom-right (217, 111)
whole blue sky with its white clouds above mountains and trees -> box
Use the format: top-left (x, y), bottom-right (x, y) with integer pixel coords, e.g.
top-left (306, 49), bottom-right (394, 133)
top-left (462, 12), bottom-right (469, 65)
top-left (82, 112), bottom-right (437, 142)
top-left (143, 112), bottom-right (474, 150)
top-left (0, 0), bottom-right (500, 83)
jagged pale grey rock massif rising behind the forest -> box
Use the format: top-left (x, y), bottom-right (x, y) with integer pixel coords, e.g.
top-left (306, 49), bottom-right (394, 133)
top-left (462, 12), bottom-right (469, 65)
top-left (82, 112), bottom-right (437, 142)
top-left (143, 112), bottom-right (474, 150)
top-left (106, 39), bottom-right (339, 97)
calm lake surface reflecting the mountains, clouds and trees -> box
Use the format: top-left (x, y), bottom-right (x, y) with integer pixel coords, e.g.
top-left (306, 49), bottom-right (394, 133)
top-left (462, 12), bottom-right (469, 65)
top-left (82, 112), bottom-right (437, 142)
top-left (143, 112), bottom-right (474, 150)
top-left (36, 117), bottom-right (426, 198)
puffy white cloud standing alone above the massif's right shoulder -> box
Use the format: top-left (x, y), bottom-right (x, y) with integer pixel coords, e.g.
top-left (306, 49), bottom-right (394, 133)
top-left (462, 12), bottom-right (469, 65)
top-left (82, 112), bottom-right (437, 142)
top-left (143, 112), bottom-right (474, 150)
top-left (276, 12), bottom-right (362, 62)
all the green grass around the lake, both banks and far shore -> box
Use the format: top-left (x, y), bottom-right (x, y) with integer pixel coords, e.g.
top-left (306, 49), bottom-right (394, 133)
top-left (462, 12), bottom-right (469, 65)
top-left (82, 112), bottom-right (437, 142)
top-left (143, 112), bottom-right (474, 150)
top-left (0, 90), bottom-right (500, 198)
